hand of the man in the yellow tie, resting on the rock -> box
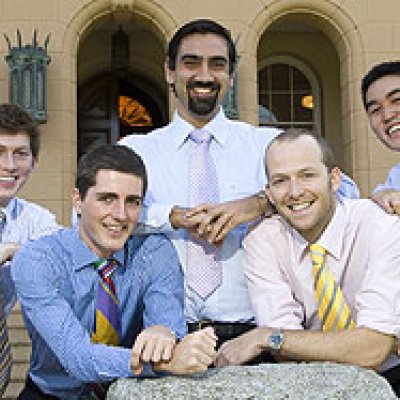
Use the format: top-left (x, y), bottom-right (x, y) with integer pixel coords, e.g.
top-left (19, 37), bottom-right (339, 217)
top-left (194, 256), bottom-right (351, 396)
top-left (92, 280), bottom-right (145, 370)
top-left (214, 328), bottom-right (269, 367)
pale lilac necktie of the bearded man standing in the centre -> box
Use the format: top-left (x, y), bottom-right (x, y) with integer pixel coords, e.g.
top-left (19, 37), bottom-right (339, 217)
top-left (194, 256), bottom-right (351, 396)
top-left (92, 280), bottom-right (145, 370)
top-left (186, 129), bottom-right (222, 299)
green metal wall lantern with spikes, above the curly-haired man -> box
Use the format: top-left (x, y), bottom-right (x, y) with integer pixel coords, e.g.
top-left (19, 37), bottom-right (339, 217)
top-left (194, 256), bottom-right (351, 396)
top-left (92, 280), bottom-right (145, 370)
top-left (4, 29), bottom-right (50, 123)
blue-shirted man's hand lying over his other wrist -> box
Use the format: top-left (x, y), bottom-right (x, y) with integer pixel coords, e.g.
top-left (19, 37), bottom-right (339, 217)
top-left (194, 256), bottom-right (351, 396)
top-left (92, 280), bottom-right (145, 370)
top-left (131, 325), bottom-right (176, 375)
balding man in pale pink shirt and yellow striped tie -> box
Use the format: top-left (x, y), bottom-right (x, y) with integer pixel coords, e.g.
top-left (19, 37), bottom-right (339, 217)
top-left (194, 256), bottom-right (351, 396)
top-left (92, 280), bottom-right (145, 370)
top-left (216, 129), bottom-right (400, 395)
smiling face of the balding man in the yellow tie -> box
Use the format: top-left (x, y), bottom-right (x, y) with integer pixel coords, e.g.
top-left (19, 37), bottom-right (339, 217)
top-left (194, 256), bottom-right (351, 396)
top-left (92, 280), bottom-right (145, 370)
top-left (266, 136), bottom-right (340, 243)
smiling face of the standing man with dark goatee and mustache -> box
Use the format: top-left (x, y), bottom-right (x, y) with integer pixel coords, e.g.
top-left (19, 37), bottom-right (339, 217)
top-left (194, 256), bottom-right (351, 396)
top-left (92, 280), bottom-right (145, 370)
top-left (166, 33), bottom-right (232, 127)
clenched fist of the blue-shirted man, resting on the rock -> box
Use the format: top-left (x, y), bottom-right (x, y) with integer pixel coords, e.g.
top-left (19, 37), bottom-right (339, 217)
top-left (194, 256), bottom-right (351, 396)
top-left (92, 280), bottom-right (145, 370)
top-left (154, 327), bottom-right (217, 375)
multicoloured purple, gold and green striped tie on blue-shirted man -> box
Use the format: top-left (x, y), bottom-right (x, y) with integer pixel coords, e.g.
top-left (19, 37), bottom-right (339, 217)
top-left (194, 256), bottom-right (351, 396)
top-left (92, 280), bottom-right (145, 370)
top-left (92, 259), bottom-right (121, 346)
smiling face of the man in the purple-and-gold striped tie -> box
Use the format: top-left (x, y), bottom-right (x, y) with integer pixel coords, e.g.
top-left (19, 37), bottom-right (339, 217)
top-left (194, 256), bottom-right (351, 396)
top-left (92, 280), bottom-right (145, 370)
top-left (72, 170), bottom-right (143, 258)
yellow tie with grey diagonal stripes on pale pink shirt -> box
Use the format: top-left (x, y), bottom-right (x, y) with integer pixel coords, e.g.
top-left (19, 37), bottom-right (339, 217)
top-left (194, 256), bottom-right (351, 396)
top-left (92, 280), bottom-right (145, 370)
top-left (310, 243), bottom-right (355, 331)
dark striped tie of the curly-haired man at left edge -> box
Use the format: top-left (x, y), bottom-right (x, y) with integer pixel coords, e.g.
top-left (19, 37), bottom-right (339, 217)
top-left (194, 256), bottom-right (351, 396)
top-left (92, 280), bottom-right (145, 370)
top-left (0, 210), bottom-right (12, 397)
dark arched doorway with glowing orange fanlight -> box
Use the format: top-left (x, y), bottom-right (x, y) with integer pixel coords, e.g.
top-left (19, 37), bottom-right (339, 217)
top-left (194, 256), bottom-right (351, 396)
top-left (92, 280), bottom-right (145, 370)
top-left (77, 12), bottom-right (169, 159)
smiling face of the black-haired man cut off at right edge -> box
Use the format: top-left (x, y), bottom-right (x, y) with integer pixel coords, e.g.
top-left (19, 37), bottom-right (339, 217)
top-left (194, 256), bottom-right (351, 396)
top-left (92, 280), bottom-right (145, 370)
top-left (366, 75), bottom-right (400, 151)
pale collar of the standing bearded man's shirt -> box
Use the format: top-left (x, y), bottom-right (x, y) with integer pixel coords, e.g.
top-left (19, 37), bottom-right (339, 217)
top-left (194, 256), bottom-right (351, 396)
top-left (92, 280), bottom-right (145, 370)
top-left (170, 107), bottom-right (229, 149)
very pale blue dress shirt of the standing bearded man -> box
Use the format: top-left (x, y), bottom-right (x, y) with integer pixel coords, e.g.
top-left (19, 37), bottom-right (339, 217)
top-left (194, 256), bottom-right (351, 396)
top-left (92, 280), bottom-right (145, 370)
top-left (120, 109), bottom-right (279, 322)
